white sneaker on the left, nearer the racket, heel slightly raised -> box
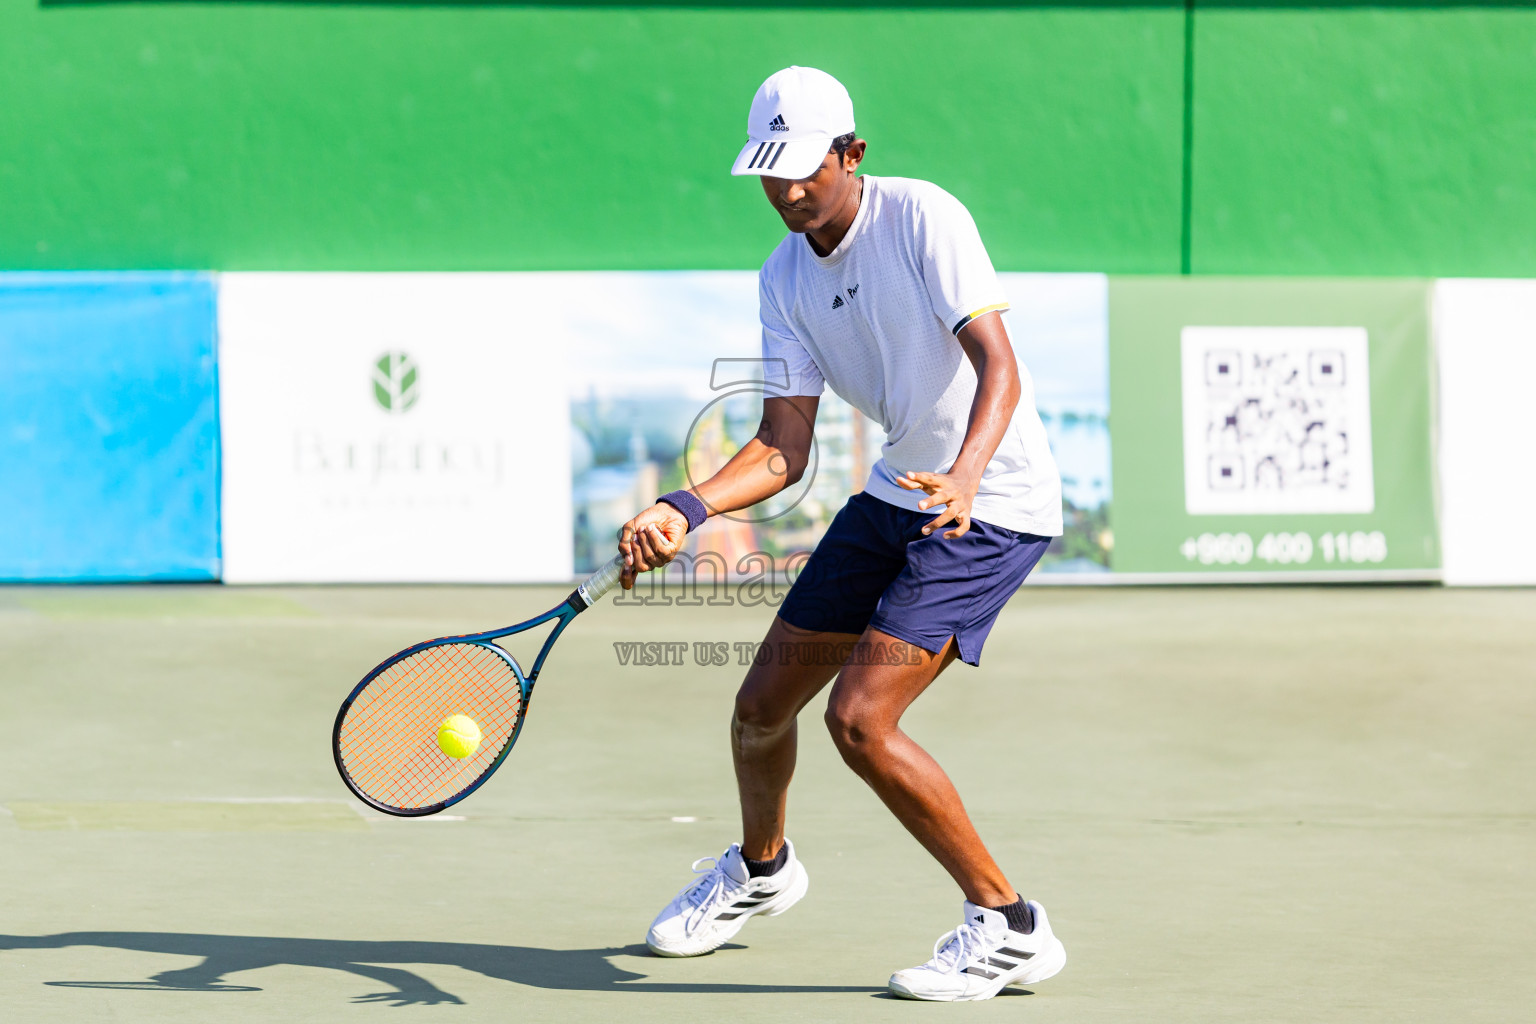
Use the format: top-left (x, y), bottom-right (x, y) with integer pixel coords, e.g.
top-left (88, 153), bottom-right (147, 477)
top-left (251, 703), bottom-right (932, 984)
top-left (645, 840), bottom-right (809, 956)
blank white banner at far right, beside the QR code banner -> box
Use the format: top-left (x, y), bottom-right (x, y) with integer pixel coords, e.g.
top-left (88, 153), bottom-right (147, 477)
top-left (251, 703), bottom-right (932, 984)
top-left (1435, 281), bottom-right (1536, 586)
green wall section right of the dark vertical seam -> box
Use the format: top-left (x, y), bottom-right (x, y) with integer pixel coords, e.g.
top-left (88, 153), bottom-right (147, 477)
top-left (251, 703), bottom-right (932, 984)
top-left (1190, 6), bottom-right (1536, 276)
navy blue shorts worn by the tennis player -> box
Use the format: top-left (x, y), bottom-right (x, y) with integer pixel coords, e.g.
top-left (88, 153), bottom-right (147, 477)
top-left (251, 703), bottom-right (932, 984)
top-left (779, 494), bottom-right (1051, 665)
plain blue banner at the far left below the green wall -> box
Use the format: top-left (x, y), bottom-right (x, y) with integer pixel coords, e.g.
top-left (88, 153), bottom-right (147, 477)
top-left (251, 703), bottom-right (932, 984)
top-left (0, 273), bottom-right (220, 580)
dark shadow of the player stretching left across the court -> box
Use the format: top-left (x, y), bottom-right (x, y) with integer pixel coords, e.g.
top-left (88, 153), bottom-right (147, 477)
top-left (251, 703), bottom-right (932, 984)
top-left (0, 932), bottom-right (872, 1006)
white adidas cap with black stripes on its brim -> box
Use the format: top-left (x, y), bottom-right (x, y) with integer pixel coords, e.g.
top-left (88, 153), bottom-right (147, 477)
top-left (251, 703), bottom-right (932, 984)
top-left (731, 66), bottom-right (854, 178)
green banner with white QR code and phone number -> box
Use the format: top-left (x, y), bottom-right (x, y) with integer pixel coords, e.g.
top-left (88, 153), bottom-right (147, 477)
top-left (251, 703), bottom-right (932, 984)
top-left (1109, 278), bottom-right (1441, 582)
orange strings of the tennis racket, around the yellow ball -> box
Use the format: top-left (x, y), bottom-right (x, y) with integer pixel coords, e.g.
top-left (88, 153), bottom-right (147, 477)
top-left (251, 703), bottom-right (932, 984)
top-left (336, 643), bottom-right (522, 811)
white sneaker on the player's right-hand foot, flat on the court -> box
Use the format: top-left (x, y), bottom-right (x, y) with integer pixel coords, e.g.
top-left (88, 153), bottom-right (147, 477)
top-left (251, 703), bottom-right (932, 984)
top-left (891, 900), bottom-right (1066, 1003)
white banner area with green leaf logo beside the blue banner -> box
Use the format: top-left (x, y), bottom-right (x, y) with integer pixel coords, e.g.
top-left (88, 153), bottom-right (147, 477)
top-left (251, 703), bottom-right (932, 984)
top-left (218, 273), bottom-right (573, 583)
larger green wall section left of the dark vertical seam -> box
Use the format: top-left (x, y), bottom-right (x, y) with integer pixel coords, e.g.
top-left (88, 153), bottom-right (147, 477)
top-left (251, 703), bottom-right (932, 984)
top-left (0, 0), bottom-right (1183, 272)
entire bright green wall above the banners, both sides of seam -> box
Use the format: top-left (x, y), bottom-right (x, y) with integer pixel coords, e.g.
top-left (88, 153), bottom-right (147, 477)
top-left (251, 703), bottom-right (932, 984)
top-left (9, 0), bottom-right (1536, 276)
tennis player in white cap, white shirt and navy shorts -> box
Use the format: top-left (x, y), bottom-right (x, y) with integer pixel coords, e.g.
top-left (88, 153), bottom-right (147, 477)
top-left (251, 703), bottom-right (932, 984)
top-left (619, 68), bottom-right (1066, 1001)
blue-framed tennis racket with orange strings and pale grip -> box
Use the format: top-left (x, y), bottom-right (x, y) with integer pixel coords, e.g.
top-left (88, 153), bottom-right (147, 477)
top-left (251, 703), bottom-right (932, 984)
top-left (330, 556), bottom-right (624, 817)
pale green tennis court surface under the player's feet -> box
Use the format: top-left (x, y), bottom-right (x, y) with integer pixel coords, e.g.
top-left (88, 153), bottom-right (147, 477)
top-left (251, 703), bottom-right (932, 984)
top-left (0, 586), bottom-right (1536, 1024)
